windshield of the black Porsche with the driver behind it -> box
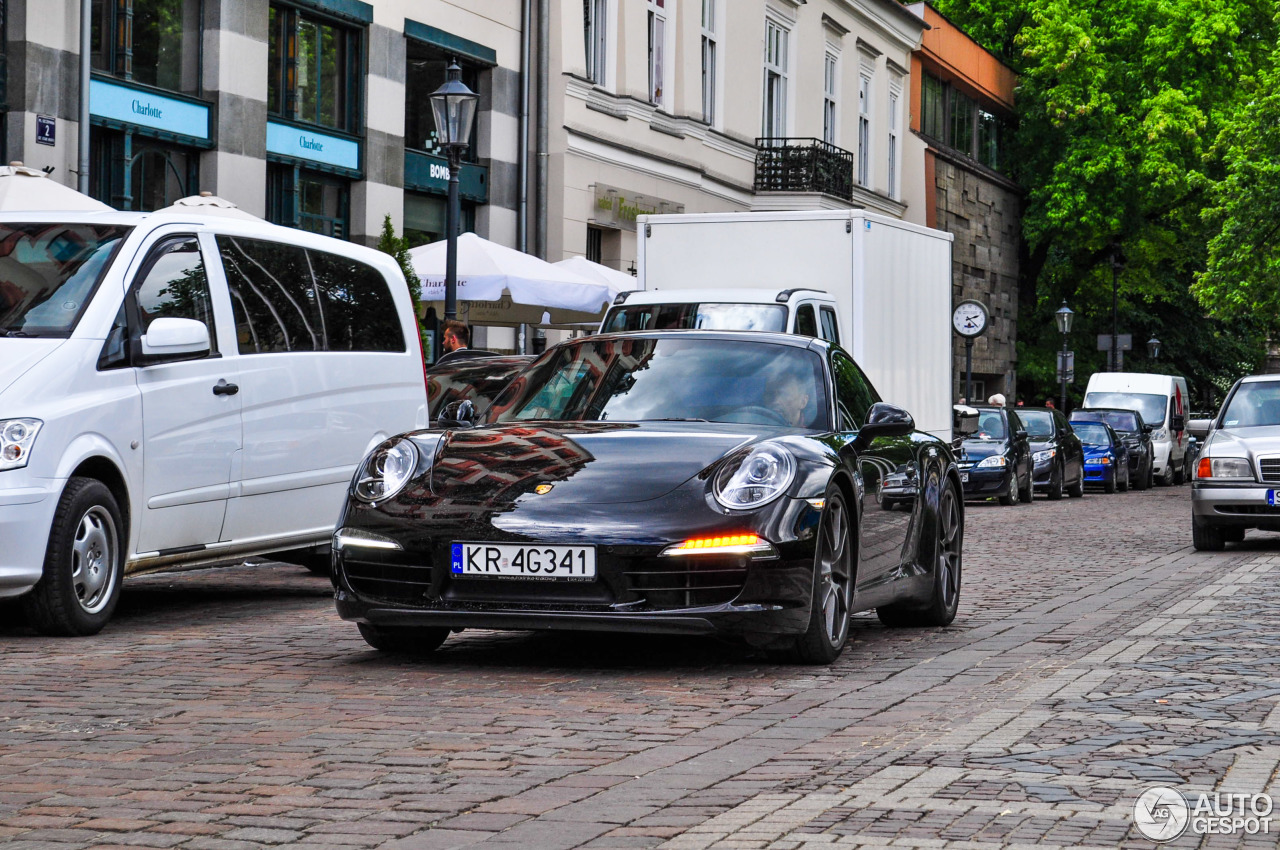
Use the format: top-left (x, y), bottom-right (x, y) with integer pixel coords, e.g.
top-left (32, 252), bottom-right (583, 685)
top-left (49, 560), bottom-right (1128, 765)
top-left (490, 337), bottom-right (829, 430)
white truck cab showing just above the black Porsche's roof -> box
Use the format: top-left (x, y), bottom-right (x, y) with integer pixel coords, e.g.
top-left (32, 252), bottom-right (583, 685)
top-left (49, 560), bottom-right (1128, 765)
top-left (600, 288), bottom-right (847, 346)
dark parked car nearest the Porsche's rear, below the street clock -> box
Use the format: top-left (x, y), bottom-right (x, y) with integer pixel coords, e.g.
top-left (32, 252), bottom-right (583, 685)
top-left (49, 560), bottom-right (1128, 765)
top-left (956, 405), bottom-right (1032, 504)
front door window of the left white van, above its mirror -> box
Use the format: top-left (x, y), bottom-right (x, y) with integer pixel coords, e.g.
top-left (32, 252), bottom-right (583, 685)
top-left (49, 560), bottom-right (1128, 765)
top-left (133, 236), bottom-right (218, 353)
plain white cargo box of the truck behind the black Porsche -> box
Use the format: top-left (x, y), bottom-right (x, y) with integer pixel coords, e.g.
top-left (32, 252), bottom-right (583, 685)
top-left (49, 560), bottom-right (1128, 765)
top-left (624, 210), bottom-right (952, 439)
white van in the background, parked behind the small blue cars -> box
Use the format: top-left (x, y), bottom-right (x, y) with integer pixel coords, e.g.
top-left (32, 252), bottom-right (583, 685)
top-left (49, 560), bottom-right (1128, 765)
top-left (1084, 373), bottom-right (1190, 484)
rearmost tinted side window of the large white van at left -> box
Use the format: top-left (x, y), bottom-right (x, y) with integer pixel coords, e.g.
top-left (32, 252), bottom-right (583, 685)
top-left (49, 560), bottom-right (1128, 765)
top-left (307, 250), bottom-right (404, 351)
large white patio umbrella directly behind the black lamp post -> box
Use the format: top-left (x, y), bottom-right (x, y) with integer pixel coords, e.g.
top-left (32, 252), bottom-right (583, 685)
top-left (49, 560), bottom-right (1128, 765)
top-left (408, 233), bottom-right (614, 325)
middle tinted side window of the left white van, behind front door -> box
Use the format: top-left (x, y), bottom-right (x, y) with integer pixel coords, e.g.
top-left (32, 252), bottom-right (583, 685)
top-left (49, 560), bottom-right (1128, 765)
top-left (218, 236), bottom-right (324, 355)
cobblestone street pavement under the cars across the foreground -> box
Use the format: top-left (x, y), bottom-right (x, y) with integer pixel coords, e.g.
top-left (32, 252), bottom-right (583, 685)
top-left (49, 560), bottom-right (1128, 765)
top-left (0, 486), bottom-right (1280, 850)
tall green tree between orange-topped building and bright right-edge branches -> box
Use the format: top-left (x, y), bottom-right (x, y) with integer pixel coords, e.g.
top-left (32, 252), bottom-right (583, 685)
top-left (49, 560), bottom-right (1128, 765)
top-left (937, 0), bottom-right (1280, 409)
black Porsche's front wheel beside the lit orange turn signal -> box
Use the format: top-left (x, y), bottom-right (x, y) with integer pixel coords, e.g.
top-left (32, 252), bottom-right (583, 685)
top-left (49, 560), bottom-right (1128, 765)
top-left (792, 485), bottom-right (854, 664)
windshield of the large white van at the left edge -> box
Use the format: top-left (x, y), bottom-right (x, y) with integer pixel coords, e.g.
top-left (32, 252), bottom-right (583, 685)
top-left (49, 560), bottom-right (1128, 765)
top-left (0, 221), bottom-right (133, 337)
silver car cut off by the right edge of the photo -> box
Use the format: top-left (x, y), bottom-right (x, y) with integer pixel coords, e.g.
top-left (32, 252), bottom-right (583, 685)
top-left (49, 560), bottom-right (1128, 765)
top-left (1192, 375), bottom-right (1280, 552)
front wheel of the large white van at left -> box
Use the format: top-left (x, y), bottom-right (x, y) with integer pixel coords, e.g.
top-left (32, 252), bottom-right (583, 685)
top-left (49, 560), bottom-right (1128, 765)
top-left (22, 477), bottom-right (124, 636)
